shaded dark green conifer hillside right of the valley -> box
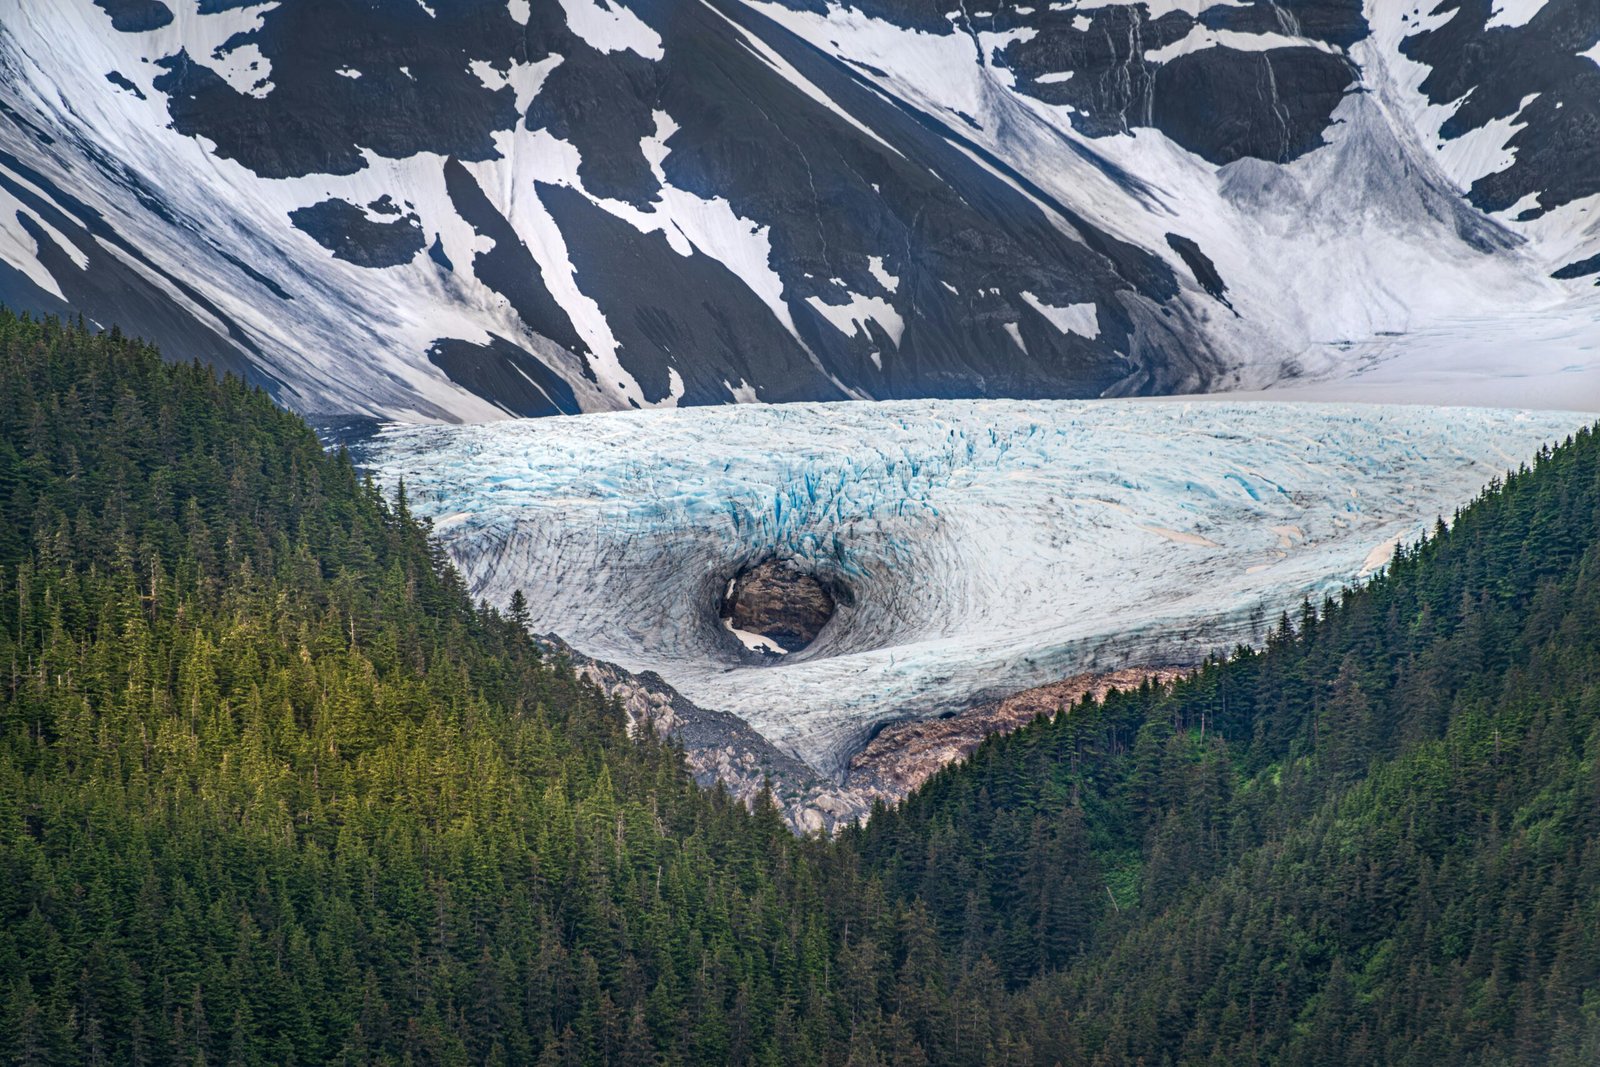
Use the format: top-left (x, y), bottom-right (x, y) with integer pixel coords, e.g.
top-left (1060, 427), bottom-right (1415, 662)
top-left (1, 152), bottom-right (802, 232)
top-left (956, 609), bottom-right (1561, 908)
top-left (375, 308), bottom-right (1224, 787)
top-left (851, 415), bottom-right (1600, 1064)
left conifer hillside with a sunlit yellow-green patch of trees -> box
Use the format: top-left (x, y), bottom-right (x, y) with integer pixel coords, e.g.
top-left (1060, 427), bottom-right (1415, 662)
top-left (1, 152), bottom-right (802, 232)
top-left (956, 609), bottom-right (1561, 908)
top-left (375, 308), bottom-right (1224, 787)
top-left (0, 317), bottom-right (864, 1064)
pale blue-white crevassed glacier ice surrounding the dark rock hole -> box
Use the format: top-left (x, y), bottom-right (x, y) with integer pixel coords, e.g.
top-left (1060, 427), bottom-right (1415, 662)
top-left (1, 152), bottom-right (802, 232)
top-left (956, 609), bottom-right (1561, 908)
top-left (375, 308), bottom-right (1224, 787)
top-left (363, 402), bottom-right (1592, 773)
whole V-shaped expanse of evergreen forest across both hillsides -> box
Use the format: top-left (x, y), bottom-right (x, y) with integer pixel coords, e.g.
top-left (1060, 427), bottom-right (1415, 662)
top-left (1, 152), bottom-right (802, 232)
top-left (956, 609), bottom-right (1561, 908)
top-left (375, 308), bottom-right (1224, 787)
top-left (0, 315), bottom-right (1600, 1065)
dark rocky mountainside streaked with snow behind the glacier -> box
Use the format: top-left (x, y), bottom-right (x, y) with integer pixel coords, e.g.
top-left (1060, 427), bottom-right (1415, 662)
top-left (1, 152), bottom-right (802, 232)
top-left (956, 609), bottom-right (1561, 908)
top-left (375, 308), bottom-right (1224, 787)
top-left (0, 0), bottom-right (1600, 421)
